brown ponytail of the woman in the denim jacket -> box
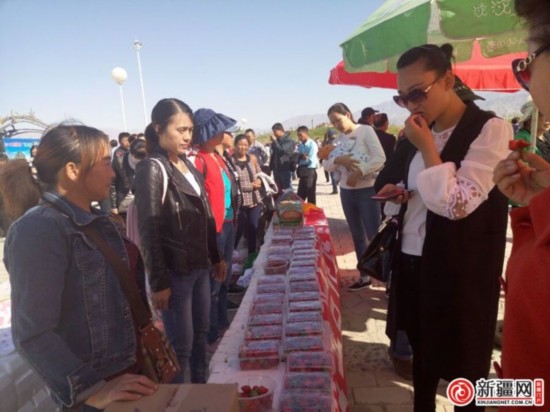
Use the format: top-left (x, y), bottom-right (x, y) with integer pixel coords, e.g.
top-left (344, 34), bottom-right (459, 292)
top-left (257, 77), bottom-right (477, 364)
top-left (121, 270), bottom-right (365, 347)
top-left (0, 159), bottom-right (42, 221)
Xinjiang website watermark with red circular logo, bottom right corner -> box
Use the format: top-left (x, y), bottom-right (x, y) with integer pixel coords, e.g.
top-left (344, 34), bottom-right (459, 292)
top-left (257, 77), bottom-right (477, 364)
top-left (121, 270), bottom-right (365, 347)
top-left (447, 378), bottom-right (544, 406)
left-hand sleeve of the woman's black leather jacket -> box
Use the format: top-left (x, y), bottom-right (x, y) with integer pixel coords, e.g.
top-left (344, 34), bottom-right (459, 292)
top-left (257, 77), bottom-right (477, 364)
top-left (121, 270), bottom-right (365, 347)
top-left (134, 159), bottom-right (171, 292)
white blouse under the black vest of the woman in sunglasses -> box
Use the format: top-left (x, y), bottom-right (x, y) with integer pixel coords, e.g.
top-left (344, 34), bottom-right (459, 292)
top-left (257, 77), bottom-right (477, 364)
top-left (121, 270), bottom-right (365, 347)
top-left (401, 117), bottom-right (513, 256)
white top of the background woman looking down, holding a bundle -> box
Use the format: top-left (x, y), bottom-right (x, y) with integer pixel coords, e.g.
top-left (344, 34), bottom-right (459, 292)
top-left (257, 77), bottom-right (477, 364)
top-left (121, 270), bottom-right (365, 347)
top-left (323, 125), bottom-right (386, 189)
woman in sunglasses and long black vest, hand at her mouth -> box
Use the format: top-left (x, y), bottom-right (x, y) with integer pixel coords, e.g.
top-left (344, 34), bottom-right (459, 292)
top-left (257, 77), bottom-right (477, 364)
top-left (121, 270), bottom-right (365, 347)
top-left (376, 45), bottom-right (512, 412)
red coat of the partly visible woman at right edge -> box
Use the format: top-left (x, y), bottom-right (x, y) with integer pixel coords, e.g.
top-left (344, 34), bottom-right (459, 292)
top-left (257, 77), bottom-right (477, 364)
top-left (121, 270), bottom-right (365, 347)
top-left (502, 189), bottom-right (550, 412)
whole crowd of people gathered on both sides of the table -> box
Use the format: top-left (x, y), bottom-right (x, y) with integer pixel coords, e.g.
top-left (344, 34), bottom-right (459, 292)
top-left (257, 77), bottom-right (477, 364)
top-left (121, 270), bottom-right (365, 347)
top-left (0, 0), bottom-right (550, 412)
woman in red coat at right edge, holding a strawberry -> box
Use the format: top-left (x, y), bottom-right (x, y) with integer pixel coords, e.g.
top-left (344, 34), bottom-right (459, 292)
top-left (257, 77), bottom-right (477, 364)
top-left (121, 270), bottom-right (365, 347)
top-left (494, 0), bottom-right (550, 411)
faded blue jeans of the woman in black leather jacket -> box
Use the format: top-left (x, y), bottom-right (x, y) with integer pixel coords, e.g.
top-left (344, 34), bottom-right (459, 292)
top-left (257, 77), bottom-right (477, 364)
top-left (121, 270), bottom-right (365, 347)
top-left (162, 269), bottom-right (210, 383)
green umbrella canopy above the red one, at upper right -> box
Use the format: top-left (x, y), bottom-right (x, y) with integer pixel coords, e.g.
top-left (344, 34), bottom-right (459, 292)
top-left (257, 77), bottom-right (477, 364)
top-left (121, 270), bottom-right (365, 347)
top-left (341, 0), bottom-right (527, 73)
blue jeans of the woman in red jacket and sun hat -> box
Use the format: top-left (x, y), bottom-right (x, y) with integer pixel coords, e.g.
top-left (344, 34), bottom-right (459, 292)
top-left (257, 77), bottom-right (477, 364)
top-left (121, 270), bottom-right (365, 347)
top-left (207, 221), bottom-right (235, 343)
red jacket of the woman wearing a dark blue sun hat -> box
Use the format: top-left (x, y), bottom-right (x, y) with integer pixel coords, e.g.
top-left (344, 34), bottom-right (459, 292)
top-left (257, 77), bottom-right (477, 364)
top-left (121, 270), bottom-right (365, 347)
top-left (195, 150), bottom-right (229, 233)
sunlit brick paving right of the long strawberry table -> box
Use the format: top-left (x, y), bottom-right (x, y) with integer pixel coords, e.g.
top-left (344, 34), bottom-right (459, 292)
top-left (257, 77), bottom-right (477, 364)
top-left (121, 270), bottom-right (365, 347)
top-left (317, 173), bottom-right (511, 412)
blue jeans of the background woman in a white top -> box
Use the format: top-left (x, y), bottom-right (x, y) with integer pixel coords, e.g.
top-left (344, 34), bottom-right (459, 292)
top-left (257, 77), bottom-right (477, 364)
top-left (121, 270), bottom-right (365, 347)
top-left (340, 187), bottom-right (380, 277)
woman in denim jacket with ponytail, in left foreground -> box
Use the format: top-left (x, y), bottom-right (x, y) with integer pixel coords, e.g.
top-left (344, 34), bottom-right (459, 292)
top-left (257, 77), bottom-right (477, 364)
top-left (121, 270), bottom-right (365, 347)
top-left (2, 125), bottom-right (156, 410)
